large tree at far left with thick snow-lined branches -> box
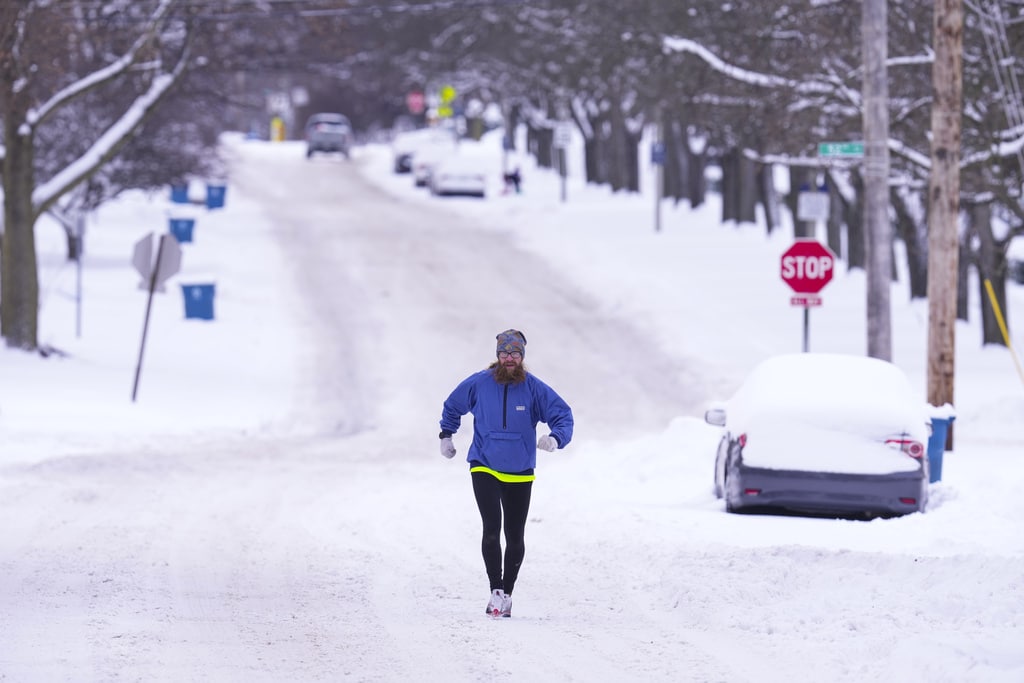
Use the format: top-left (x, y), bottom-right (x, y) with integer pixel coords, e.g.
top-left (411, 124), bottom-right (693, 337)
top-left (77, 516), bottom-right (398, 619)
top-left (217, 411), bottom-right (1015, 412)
top-left (0, 0), bottom-right (190, 349)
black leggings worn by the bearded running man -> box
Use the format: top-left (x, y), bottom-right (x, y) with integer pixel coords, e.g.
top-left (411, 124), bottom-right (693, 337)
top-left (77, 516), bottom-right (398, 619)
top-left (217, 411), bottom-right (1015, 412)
top-left (470, 472), bottom-right (534, 595)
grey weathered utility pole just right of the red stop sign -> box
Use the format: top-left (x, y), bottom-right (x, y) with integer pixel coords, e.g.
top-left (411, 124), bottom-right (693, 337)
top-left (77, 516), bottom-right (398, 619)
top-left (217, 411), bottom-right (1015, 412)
top-left (861, 0), bottom-right (893, 360)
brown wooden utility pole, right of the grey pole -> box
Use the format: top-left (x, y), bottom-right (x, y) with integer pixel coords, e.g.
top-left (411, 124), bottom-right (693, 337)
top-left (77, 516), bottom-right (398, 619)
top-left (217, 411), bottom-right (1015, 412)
top-left (928, 0), bottom-right (964, 430)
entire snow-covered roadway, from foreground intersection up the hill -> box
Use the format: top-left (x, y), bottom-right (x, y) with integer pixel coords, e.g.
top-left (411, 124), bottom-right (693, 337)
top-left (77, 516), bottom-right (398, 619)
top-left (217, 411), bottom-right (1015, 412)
top-left (0, 140), bottom-right (1024, 683)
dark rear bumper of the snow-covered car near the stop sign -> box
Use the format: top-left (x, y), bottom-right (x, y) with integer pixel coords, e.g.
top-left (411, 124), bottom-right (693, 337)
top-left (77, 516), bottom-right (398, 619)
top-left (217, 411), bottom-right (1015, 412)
top-left (727, 465), bottom-right (928, 515)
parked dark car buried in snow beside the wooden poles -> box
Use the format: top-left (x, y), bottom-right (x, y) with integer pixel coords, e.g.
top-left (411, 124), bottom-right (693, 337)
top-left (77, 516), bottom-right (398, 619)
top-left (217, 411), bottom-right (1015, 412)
top-left (705, 353), bottom-right (931, 516)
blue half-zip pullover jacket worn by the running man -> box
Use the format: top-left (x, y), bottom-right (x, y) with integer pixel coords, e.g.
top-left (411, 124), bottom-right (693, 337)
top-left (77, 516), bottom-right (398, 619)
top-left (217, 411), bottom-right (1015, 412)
top-left (440, 370), bottom-right (572, 473)
